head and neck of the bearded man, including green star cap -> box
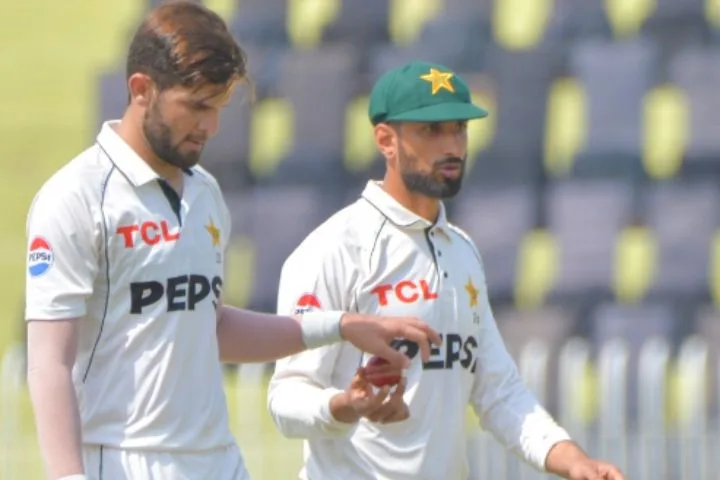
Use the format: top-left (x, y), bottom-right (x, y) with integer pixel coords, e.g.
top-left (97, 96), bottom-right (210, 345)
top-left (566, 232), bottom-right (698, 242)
top-left (368, 61), bottom-right (488, 206)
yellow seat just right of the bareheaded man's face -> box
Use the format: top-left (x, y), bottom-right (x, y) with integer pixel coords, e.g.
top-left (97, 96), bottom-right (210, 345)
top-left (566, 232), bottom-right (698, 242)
top-left (250, 98), bottom-right (294, 177)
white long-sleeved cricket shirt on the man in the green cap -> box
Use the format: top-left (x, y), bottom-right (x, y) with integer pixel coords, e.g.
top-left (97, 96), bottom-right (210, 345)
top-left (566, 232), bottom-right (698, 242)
top-left (268, 182), bottom-right (569, 480)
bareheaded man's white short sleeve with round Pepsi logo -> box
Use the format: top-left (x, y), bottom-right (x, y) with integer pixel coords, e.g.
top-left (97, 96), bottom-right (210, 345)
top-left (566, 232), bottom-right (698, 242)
top-left (25, 181), bottom-right (101, 320)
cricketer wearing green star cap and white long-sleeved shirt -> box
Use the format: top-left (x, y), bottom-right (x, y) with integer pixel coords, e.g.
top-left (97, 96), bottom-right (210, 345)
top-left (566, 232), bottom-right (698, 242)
top-left (268, 62), bottom-right (623, 480)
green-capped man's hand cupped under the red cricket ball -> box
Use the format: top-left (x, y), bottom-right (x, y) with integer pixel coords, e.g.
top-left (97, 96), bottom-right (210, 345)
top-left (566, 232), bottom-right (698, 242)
top-left (330, 368), bottom-right (410, 423)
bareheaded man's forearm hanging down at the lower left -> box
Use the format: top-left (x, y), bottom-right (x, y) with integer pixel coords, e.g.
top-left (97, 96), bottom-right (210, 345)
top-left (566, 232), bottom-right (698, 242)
top-left (28, 364), bottom-right (84, 480)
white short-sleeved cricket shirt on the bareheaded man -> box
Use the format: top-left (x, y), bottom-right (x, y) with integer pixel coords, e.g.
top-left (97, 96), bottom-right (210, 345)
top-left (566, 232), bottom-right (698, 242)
top-left (26, 122), bottom-right (233, 451)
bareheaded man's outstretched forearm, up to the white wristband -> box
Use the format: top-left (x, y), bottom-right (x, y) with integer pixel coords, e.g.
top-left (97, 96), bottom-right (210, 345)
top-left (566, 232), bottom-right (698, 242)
top-left (217, 306), bottom-right (305, 363)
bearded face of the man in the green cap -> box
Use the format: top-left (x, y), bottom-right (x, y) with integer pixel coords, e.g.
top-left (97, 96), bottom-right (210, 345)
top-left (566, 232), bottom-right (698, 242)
top-left (395, 121), bottom-right (467, 199)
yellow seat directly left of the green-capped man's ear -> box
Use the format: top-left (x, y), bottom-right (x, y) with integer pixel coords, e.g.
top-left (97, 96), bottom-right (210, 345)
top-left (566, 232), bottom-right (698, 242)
top-left (345, 96), bottom-right (378, 172)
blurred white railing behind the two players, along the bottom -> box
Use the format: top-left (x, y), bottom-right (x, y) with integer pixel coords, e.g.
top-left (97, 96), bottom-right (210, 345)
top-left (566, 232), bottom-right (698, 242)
top-left (0, 337), bottom-right (720, 480)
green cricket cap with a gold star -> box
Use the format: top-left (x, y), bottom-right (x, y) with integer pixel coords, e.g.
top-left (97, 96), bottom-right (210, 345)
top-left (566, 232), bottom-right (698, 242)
top-left (368, 61), bottom-right (488, 125)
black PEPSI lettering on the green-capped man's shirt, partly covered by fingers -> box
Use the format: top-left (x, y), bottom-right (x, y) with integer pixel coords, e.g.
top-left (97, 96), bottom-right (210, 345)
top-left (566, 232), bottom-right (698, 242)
top-left (391, 333), bottom-right (478, 373)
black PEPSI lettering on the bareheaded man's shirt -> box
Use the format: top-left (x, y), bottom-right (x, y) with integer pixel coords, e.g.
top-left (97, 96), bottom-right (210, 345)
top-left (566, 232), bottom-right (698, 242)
top-left (130, 275), bottom-right (222, 314)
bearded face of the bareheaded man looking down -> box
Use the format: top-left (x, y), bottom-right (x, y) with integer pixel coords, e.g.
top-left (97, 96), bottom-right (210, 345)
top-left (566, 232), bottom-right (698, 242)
top-left (142, 85), bottom-right (232, 168)
